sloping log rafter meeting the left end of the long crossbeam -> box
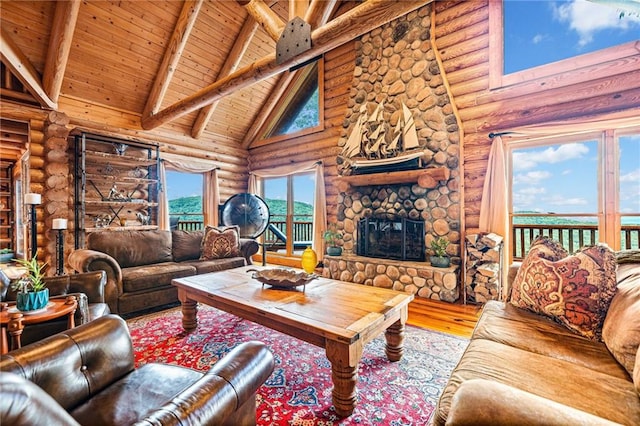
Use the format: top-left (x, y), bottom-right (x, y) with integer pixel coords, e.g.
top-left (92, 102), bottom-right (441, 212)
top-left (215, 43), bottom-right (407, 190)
top-left (142, 0), bottom-right (203, 116)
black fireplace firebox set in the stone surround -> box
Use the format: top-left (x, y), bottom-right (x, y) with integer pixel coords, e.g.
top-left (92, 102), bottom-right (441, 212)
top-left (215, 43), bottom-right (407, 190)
top-left (356, 217), bottom-right (425, 261)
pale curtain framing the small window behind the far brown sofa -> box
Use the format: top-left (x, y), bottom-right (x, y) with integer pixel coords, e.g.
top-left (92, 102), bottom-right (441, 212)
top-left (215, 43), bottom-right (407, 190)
top-left (158, 153), bottom-right (220, 229)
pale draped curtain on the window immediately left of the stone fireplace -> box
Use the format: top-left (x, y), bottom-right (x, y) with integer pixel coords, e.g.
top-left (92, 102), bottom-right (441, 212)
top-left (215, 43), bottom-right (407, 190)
top-left (248, 161), bottom-right (327, 253)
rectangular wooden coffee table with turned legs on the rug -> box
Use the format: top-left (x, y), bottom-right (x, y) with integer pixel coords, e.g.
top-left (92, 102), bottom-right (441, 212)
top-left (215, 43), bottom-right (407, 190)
top-left (172, 265), bottom-right (413, 416)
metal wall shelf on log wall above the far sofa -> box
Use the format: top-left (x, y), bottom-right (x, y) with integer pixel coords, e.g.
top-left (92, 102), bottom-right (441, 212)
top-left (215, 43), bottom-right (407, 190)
top-left (75, 133), bottom-right (160, 248)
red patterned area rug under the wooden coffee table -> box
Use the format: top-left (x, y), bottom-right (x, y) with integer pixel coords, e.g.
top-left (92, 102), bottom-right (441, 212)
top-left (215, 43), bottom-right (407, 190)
top-left (127, 305), bottom-right (468, 426)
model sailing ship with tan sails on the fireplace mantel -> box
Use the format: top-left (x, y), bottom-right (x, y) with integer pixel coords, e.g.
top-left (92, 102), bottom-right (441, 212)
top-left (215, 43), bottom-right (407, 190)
top-left (338, 102), bottom-right (424, 175)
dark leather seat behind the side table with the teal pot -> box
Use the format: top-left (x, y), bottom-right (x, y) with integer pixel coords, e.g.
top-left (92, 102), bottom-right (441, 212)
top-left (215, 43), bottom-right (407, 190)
top-left (0, 271), bottom-right (110, 346)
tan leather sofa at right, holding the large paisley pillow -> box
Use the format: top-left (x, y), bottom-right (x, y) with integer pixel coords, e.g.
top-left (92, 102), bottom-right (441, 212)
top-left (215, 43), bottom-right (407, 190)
top-left (434, 255), bottom-right (640, 426)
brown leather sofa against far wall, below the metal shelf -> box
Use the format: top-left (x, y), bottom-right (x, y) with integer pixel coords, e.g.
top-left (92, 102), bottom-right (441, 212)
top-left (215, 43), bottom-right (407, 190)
top-left (68, 230), bottom-right (259, 314)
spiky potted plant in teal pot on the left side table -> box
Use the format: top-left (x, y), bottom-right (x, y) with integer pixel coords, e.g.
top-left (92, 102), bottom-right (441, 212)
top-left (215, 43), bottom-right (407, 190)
top-left (12, 256), bottom-right (49, 311)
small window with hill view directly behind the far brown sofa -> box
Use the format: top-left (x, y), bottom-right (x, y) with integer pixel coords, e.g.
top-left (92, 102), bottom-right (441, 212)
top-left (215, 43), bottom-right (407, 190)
top-left (166, 170), bottom-right (204, 231)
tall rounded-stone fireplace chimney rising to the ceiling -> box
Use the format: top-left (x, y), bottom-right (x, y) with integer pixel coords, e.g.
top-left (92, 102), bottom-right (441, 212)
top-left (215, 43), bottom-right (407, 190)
top-left (324, 5), bottom-right (461, 301)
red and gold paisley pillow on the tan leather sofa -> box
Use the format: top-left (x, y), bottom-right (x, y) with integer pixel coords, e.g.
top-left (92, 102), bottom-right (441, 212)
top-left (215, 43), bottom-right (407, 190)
top-left (511, 238), bottom-right (616, 340)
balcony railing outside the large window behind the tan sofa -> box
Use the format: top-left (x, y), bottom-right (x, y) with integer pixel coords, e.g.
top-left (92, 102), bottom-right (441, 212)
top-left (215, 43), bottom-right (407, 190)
top-left (511, 225), bottom-right (640, 260)
